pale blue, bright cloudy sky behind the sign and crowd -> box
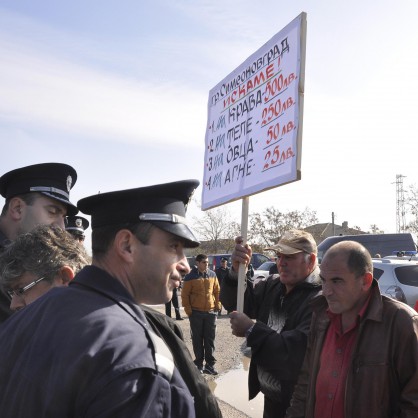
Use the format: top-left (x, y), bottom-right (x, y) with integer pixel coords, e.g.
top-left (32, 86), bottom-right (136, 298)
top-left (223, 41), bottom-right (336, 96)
top-left (0, 0), bottom-right (418, 240)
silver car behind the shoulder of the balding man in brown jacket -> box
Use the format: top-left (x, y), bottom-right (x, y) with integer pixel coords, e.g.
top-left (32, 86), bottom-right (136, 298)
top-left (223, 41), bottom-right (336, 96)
top-left (373, 258), bottom-right (418, 308)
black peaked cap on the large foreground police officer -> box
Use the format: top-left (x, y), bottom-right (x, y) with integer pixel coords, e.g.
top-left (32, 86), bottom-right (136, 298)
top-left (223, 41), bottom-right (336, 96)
top-left (77, 180), bottom-right (199, 248)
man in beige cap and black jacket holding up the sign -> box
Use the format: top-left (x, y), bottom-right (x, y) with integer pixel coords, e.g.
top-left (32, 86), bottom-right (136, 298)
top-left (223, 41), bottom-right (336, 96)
top-left (230, 230), bottom-right (321, 418)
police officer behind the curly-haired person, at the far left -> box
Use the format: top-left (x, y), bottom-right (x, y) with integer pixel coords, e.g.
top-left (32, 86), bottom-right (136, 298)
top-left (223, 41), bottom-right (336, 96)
top-left (0, 163), bottom-right (78, 323)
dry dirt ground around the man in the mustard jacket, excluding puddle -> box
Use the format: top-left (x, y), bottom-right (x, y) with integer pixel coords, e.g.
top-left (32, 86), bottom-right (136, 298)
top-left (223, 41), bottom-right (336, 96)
top-left (153, 302), bottom-right (249, 418)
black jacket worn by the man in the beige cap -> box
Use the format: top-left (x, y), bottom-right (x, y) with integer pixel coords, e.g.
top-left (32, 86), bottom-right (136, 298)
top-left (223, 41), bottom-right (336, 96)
top-left (244, 269), bottom-right (321, 405)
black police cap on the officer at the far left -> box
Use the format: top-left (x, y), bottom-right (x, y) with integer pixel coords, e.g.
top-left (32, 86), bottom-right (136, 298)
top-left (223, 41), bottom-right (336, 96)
top-left (0, 163), bottom-right (78, 215)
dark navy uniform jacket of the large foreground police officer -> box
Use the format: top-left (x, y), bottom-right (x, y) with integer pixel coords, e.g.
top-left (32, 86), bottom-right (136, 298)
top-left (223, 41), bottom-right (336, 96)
top-left (0, 266), bottom-right (195, 418)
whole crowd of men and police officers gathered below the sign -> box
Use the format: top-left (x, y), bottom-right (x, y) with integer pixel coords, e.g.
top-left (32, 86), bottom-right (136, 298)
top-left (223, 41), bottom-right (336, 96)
top-left (0, 163), bottom-right (418, 418)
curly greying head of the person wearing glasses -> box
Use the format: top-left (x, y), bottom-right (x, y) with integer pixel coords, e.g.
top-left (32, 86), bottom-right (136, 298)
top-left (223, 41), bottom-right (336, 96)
top-left (0, 225), bottom-right (89, 311)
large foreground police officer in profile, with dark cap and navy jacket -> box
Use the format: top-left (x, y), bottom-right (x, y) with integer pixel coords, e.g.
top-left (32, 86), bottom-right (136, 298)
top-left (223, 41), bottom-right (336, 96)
top-left (0, 180), bottom-right (199, 418)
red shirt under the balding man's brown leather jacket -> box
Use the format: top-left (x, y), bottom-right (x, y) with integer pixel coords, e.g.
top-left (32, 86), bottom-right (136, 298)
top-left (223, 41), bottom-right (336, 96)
top-left (315, 297), bottom-right (370, 418)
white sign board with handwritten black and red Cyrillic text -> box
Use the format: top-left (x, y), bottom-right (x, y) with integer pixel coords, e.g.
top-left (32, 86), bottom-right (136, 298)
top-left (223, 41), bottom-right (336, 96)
top-left (202, 14), bottom-right (304, 209)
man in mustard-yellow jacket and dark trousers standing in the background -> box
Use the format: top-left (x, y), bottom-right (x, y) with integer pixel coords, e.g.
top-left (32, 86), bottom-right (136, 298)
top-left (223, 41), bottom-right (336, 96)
top-left (181, 254), bottom-right (221, 375)
